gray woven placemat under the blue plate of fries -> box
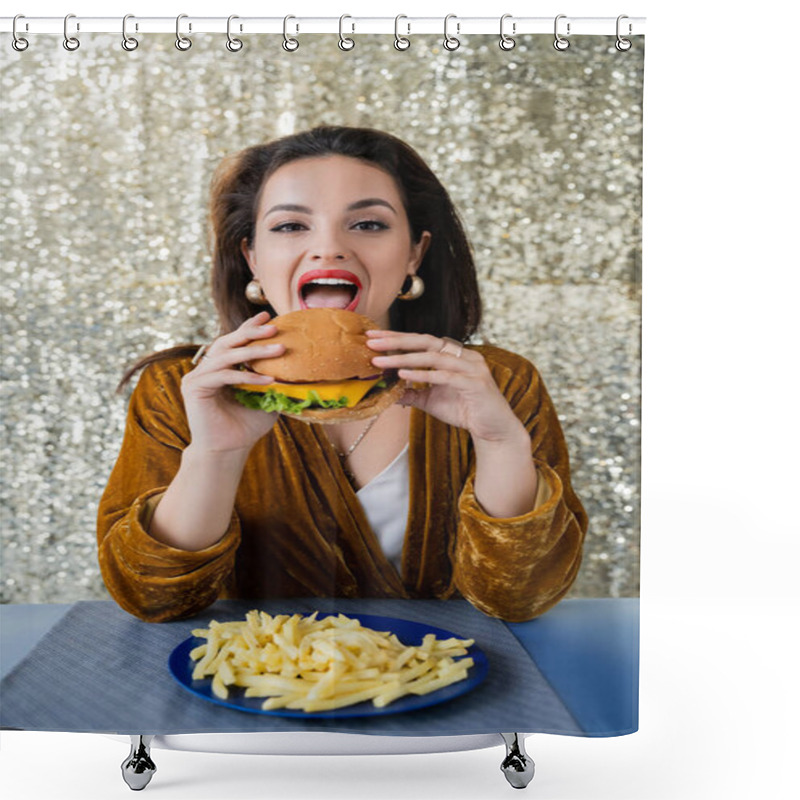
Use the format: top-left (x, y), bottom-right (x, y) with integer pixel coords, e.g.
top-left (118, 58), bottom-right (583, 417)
top-left (0, 598), bottom-right (581, 735)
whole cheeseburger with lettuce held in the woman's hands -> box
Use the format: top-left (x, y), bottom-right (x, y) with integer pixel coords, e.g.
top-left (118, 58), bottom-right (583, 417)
top-left (235, 308), bottom-right (403, 423)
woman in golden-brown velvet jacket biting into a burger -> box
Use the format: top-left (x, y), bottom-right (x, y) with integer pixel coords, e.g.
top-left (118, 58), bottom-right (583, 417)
top-left (98, 127), bottom-right (586, 621)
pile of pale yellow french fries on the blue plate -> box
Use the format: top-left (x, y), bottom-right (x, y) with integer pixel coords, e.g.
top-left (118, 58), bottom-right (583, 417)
top-left (190, 610), bottom-right (474, 712)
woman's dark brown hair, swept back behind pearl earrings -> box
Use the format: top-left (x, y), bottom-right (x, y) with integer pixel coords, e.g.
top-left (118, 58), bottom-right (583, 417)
top-left (120, 126), bottom-right (481, 386)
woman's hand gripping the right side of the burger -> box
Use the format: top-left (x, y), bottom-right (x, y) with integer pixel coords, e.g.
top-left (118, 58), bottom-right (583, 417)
top-left (367, 331), bottom-right (524, 443)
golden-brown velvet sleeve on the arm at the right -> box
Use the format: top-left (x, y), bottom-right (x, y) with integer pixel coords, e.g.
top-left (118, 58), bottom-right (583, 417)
top-left (453, 354), bottom-right (588, 622)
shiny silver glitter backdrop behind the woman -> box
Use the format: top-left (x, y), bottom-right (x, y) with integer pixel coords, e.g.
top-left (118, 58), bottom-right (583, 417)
top-left (0, 34), bottom-right (644, 602)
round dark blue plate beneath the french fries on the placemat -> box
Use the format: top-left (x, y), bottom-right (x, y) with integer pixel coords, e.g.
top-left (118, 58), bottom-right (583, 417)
top-left (169, 614), bottom-right (489, 719)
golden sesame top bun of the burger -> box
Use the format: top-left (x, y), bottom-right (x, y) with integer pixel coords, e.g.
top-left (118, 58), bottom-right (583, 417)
top-left (245, 308), bottom-right (380, 383)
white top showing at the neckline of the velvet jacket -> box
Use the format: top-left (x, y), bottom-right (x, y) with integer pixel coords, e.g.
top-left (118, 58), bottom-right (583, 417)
top-left (356, 445), bottom-right (409, 572)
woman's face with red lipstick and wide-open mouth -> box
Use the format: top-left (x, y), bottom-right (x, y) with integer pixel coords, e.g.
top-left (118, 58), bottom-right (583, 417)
top-left (242, 155), bottom-right (430, 328)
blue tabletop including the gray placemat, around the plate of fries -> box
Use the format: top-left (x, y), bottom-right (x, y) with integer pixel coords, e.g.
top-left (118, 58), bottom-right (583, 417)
top-left (0, 599), bottom-right (638, 736)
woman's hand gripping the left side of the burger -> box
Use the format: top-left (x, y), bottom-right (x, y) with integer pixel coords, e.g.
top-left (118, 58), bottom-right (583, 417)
top-left (181, 311), bottom-right (285, 453)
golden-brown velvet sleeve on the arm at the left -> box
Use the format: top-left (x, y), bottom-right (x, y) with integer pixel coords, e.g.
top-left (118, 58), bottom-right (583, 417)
top-left (97, 362), bottom-right (239, 622)
